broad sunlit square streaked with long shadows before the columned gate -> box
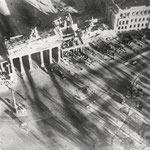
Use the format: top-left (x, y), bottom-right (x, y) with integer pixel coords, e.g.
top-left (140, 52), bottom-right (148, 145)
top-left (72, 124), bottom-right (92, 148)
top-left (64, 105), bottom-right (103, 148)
top-left (0, 40), bottom-right (150, 150)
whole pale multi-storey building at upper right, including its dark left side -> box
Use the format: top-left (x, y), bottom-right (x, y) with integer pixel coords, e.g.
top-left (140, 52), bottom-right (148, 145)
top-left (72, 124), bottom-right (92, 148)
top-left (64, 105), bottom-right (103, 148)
top-left (106, 0), bottom-right (150, 32)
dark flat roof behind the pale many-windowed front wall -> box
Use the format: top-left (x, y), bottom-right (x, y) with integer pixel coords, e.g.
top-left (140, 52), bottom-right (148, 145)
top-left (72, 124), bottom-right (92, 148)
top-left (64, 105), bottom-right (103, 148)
top-left (114, 0), bottom-right (150, 9)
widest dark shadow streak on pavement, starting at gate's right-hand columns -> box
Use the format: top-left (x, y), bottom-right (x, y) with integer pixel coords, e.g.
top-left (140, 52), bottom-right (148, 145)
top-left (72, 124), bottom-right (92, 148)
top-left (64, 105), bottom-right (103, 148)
top-left (49, 69), bottom-right (110, 148)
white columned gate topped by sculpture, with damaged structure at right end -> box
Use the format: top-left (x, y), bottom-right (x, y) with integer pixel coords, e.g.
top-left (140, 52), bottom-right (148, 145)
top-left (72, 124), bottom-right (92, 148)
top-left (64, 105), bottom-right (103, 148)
top-left (0, 14), bottom-right (84, 74)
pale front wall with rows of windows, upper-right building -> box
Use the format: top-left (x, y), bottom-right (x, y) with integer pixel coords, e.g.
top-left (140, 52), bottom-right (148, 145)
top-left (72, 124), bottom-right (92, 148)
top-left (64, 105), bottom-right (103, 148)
top-left (113, 6), bottom-right (150, 32)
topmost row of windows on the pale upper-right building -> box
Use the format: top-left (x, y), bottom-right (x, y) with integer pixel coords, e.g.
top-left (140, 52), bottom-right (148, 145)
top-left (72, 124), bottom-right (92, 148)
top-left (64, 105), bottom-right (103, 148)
top-left (120, 10), bottom-right (150, 18)
